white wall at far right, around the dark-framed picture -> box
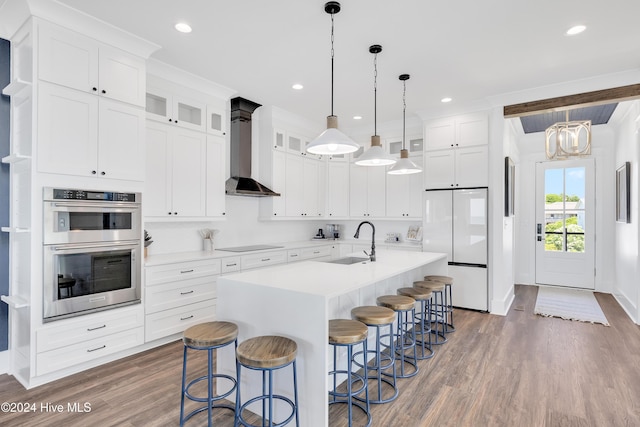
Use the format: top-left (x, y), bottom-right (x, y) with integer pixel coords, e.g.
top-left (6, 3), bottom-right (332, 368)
top-left (611, 101), bottom-right (640, 323)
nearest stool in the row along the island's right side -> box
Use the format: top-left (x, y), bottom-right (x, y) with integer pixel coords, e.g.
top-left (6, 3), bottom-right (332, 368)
top-left (329, 319), bottom-right (371, 427)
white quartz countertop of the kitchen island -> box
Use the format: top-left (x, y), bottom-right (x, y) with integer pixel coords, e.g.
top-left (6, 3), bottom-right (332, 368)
top-left (220, 250), bottom-right (446, 298)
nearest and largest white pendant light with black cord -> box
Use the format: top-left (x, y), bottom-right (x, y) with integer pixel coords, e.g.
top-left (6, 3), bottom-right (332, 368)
top-left (307, 1), bottom-right (360, 155)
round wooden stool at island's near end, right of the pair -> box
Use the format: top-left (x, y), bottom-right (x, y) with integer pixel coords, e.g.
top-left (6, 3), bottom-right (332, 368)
top-left (235, 335), bottom-right (300, 427)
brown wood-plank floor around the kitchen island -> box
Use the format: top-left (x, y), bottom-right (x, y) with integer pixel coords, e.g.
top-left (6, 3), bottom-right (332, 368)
top-left (0, 286), bottom-right (640, 427)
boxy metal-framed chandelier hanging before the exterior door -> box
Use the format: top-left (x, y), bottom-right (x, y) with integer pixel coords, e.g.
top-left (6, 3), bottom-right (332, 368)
top-left (545, 110), bottom-right (591, 160)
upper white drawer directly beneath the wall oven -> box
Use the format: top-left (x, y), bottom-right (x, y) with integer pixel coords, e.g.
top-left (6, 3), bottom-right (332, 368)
top-left (36, 305), bottom-right (144, 353)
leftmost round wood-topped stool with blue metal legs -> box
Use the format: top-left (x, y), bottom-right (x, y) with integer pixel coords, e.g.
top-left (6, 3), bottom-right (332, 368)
top-left (180, 322), bottom-right (238, 426)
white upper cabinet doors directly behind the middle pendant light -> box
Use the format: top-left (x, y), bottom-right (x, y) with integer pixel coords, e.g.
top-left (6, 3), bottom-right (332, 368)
top-left (349, 163), bottom-right (387, 218)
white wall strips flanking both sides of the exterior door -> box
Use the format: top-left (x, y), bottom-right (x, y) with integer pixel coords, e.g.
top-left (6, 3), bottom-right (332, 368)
top-left (512, 119), bottom-right (615, 292)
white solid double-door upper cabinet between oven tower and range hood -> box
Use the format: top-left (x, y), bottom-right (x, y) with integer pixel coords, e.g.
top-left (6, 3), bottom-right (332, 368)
top-left (143, 121), bottom-right (207, 218)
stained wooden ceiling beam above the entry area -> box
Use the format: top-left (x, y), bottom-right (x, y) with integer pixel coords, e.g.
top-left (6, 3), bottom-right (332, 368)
top-left (504, 84), bottom-right (640, 118)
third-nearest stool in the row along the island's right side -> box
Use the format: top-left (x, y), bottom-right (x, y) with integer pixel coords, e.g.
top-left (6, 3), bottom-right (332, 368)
top-left (376, 295), bottom-right (419, 378)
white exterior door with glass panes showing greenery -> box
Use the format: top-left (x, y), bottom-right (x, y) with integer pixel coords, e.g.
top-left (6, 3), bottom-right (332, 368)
top-left (536, 159), bottom-right (595, 289)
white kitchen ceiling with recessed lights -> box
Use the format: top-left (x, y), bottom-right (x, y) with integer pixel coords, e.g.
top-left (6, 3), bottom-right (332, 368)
top-left (59, 0), bottom-right (640, 131)
